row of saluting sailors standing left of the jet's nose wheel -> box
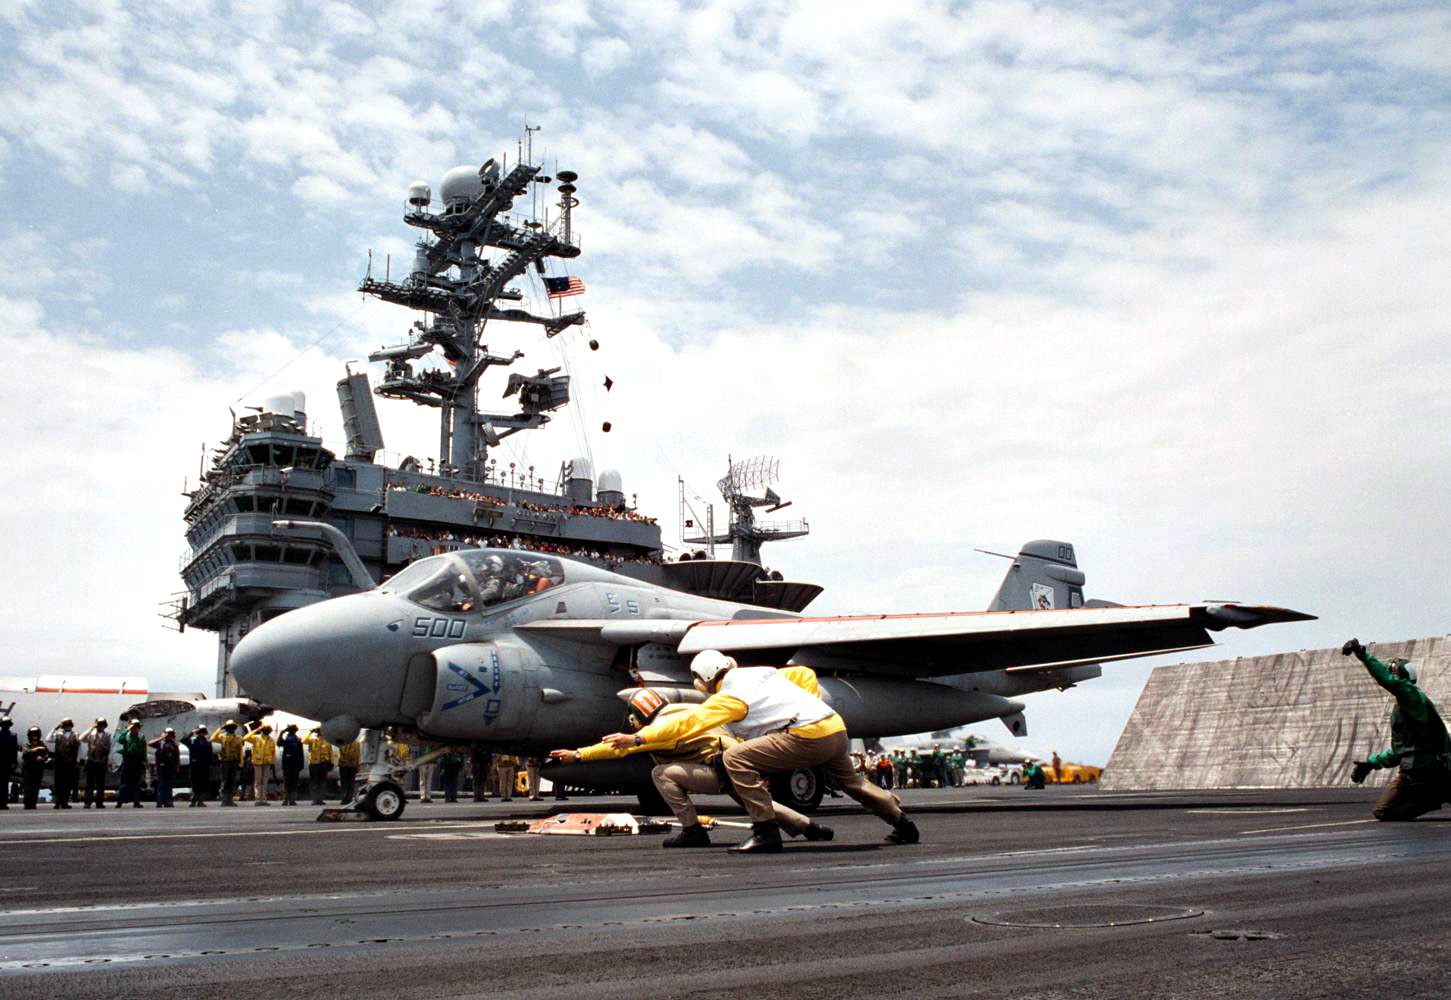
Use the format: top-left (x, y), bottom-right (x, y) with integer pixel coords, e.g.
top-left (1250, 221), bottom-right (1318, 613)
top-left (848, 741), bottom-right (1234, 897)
top-left (0, 718), bottom-right (361, 808)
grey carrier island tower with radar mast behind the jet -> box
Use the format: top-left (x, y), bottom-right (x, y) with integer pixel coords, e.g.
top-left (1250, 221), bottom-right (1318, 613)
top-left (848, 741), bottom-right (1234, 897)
top-left (170, 149), bottom-right (820, 697)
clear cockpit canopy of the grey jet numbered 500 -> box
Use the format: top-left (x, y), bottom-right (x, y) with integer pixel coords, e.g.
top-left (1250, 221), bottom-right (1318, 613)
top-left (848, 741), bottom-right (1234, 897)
top-left (379, 549), bottom-right (564, 612)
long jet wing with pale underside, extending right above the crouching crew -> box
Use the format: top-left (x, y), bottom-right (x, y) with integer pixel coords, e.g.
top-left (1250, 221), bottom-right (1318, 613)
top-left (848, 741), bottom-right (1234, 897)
top-left (521, 604), bottom-right (1315, 676)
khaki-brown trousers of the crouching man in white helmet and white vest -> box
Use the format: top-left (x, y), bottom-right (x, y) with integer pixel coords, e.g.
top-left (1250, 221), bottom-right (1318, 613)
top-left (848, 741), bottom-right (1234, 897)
top-left (726, 730), bottom-right (903, 823)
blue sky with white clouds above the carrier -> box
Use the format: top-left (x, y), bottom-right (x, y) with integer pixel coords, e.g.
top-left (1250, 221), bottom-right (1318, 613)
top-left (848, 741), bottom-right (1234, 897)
top-left (0, 0), bottom-right (1451, 763)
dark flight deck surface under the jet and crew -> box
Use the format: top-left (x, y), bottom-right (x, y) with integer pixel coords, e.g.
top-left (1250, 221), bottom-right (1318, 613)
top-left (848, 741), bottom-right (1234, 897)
top-left (0, 788), bottom-right (1451, 997)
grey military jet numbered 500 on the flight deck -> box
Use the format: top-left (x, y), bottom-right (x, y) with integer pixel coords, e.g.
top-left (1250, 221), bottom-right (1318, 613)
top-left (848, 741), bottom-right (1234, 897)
top-left (232, 531), bottom-right (1313, 819)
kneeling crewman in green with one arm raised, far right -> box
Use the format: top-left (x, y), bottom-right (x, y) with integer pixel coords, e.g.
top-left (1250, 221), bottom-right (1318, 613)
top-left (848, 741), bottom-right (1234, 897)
top-left (1341, 639), bottom-right (1451, 820)
